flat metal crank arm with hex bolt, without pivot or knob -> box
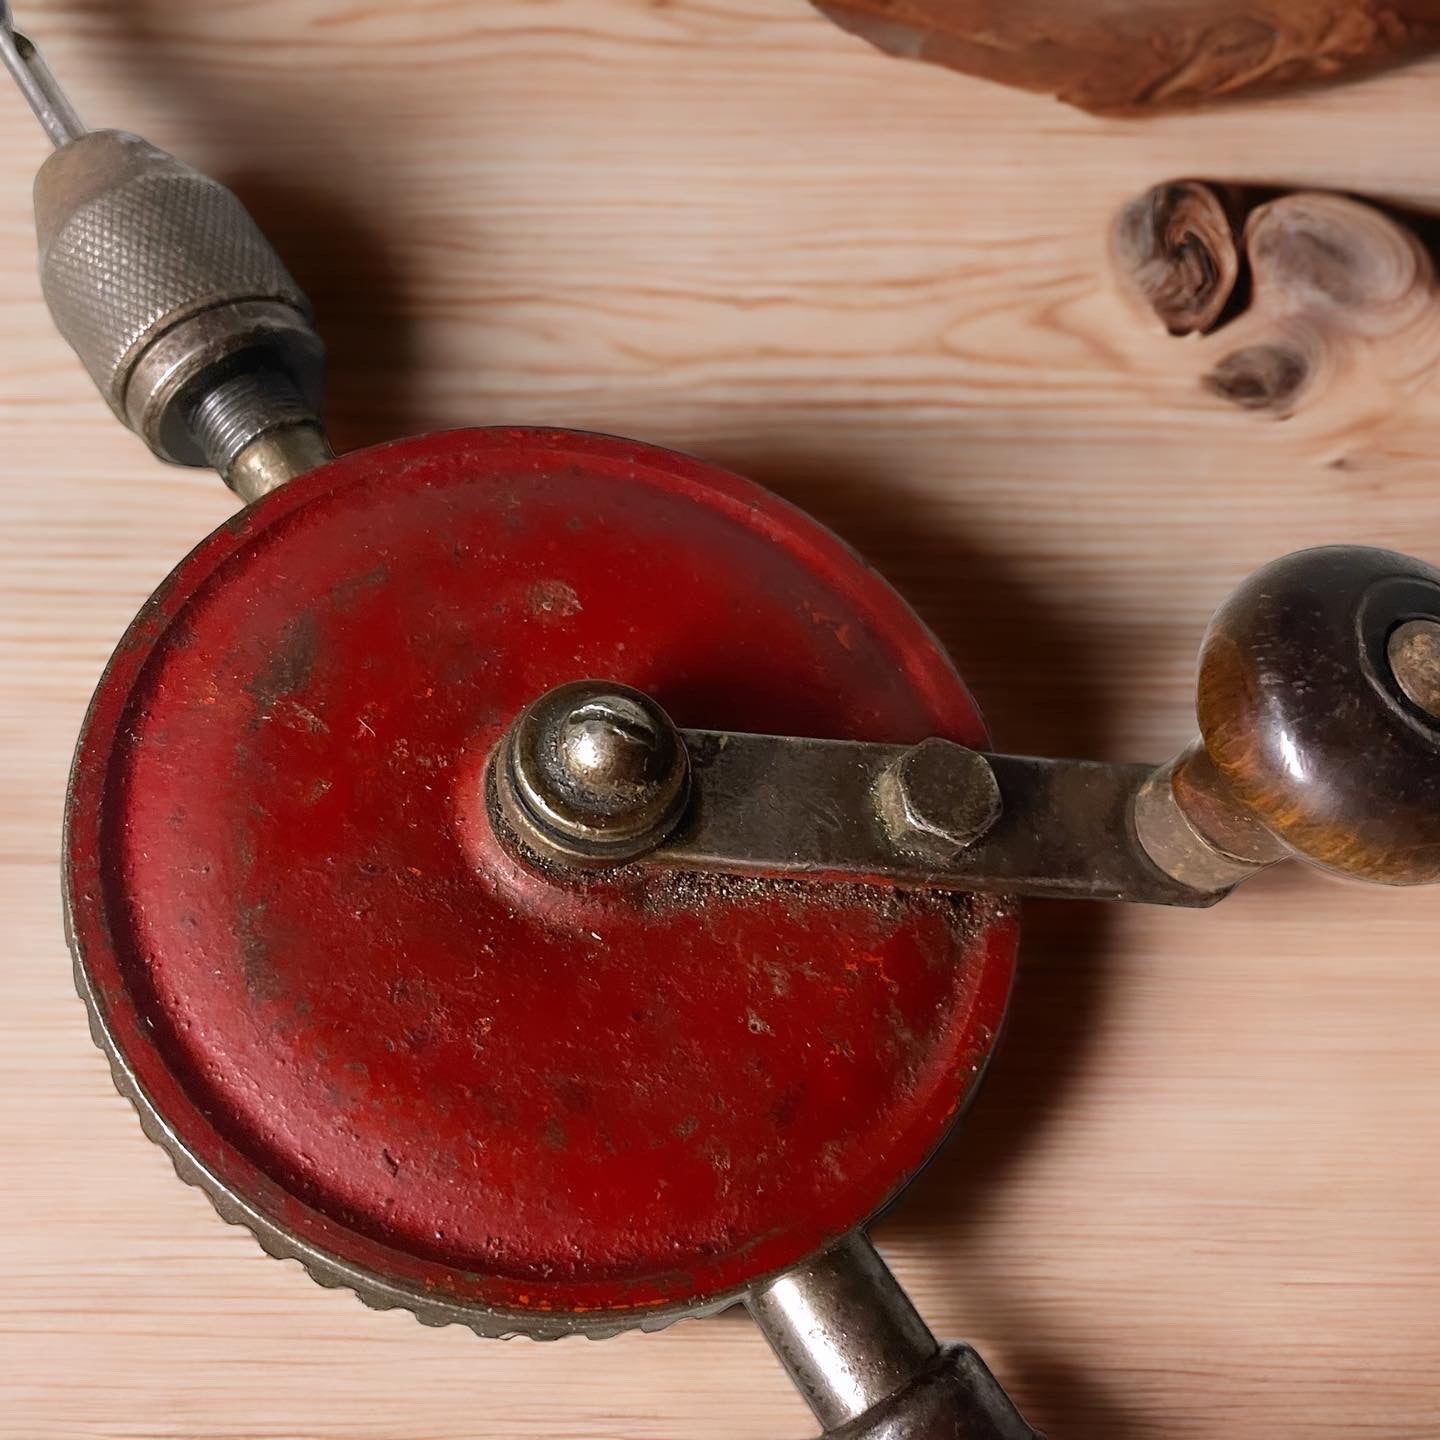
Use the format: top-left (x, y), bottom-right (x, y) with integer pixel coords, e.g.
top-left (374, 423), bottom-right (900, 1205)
top-left (651, 730), bottom-right (1225, 906)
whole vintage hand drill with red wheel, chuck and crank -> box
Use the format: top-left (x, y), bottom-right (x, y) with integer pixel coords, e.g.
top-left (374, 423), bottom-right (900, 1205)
top-left (11, 6), bottom-right (1440, 1440)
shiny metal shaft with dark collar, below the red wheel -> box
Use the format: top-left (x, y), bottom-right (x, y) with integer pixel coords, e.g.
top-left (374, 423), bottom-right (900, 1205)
top-left (746, 1233), bottom-right (1044, 1440)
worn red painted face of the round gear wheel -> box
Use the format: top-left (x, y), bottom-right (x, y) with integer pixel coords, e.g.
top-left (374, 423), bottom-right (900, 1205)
top-left (66, 429), bottom-right (1015, 1312)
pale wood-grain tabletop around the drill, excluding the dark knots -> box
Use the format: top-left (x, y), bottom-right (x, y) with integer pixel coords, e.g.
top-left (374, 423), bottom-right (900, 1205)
top-left (0, 0), bottom-right (1440, 1440)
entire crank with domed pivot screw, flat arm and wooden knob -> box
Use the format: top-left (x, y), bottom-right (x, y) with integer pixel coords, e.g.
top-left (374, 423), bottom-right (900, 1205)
top-left (488, 546), bottom-right (1440, 906)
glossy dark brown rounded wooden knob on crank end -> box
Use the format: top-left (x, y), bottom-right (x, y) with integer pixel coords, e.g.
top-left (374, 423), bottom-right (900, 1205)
top-left (1176, 546), bottom-right (1440, 886)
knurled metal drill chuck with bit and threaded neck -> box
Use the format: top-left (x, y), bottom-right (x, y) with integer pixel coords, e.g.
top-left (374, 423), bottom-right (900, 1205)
top-left (0, 3), bottom-right (331, 501)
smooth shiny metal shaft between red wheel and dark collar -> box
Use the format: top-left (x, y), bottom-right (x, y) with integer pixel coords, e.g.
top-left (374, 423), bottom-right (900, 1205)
top-left (746, 1233), bottom-right (939, 1430)
